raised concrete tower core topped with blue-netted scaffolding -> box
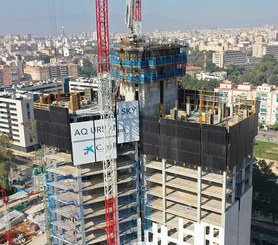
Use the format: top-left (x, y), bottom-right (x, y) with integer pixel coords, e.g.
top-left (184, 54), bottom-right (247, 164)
top-left (111, 40), bottom-right (187, 116)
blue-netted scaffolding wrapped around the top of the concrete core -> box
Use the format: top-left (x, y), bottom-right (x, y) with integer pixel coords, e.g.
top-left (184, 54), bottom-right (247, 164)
top-left (111, 40), bottom-right (187, 86)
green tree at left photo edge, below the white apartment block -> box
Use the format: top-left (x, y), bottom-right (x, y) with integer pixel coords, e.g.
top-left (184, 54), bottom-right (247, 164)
top-left (0, 134), bottom-right (13, 178)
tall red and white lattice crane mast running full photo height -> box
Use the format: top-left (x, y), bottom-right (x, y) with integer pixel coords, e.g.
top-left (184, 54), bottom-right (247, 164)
top-left (96, 0), bottom-right (118, 245)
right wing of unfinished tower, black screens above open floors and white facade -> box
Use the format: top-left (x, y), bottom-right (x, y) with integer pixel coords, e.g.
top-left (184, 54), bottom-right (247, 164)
top-left (143, 91), bottom-right (257, 245)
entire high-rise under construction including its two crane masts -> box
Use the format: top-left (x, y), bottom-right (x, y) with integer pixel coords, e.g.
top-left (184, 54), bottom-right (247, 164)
top-left (0, 0), bottom-right (258, 245)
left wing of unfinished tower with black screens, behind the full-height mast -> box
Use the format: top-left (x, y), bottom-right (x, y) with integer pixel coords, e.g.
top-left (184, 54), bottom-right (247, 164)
top-left (35, 93), bottom-right (140, 244)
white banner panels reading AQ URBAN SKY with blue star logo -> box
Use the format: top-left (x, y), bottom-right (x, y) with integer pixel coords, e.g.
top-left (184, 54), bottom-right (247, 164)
top-left (70, 101), bottom-right (139, 165)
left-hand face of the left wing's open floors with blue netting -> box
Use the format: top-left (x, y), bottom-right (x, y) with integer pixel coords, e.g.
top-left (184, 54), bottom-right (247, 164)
top-left (46, 165), bottom-right (83, 245)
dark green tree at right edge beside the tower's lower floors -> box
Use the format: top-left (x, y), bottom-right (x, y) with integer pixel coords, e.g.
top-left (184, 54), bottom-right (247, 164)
top-left (253, 160), bottom-right (278, 230)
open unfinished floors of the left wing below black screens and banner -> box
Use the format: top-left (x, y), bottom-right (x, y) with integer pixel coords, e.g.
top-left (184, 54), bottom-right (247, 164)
top-left (46, 143), bottom-right (140, 245)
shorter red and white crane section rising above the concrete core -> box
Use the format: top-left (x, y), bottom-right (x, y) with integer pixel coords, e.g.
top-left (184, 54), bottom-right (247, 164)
top-left (126, 0), bottom-right (142, 36)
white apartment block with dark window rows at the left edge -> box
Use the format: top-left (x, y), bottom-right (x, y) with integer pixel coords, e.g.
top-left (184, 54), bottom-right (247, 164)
top-left (0, 92), bottom-right (37, 152)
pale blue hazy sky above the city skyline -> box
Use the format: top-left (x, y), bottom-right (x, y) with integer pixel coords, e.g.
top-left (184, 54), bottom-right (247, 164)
top-left (0, 0), bottom-right (278, 34)
